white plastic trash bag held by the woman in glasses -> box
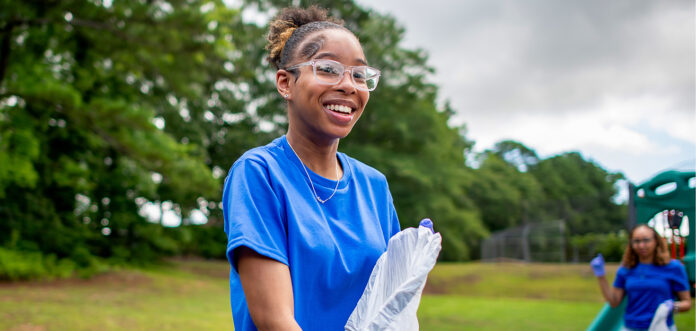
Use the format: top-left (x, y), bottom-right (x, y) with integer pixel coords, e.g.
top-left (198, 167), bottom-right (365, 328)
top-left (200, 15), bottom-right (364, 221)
top-left (345, 219), bottom-right (442, 331)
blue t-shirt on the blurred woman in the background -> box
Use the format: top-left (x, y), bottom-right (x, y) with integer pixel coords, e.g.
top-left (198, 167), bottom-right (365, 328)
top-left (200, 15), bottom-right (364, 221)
top-left (614, 260), bottom-right (689, 329)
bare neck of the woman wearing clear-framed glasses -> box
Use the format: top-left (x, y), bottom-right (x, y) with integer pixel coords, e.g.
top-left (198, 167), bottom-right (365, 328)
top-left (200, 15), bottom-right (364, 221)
top-left (286, 130), bottom-right (343, 180)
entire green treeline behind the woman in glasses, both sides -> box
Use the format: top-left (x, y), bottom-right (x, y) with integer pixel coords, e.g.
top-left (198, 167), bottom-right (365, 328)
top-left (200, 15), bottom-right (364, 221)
top-left (0, 0), bottom-right (623, 278)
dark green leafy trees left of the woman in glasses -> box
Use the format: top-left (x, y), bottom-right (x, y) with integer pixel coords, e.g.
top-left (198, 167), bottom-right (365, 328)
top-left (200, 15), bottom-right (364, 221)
top-left (0, 1), bottom-right (234, 259)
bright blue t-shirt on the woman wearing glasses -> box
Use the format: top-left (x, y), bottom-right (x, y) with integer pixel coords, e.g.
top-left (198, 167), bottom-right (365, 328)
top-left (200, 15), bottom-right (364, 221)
top-left (222, 136), bottom-right (399, 331)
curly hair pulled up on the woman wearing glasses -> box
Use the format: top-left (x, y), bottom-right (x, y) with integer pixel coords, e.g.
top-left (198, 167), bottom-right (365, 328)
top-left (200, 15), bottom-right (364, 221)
top-left (266, 6), bottom-right (352, 69)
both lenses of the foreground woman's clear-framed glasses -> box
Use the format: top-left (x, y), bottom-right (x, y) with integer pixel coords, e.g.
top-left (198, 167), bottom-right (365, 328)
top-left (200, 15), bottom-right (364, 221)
top-left (314, 60), bottom-right (379, 91)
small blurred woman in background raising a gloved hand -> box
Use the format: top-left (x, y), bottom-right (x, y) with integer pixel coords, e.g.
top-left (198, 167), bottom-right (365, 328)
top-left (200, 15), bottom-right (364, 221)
top-left (590, 225), bottom-right (691, 330)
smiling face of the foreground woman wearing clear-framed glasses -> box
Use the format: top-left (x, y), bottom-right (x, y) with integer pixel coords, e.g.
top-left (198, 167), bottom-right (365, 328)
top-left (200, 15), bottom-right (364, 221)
top-left (276, 29), bottom-right (370, 143)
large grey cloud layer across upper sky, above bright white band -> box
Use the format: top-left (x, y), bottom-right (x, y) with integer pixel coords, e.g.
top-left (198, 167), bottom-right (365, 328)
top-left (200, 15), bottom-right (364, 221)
top-left (362, 0), bottom-right (695, 114)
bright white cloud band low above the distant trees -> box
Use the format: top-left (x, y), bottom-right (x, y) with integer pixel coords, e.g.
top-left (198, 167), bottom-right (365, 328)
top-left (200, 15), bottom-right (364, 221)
top-left (469, 93), bottom-right (694, 156)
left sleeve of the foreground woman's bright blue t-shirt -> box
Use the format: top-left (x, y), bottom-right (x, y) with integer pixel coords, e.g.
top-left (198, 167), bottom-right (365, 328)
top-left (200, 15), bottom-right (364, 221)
top-left (222, 159), bottom-right (288, 268)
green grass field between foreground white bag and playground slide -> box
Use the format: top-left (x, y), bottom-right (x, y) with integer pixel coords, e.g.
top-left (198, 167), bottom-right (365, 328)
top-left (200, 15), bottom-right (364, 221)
top-left (418, 263), bottom-right (695, 331)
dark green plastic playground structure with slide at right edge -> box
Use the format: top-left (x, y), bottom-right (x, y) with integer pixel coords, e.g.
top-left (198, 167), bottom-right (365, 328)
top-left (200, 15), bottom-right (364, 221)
top-left (587, 171), bottom-right (696, 331)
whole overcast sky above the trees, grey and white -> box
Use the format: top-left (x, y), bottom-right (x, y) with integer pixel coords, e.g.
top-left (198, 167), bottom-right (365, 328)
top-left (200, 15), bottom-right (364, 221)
top-left (358, 0), bottom-right (696, 187)
